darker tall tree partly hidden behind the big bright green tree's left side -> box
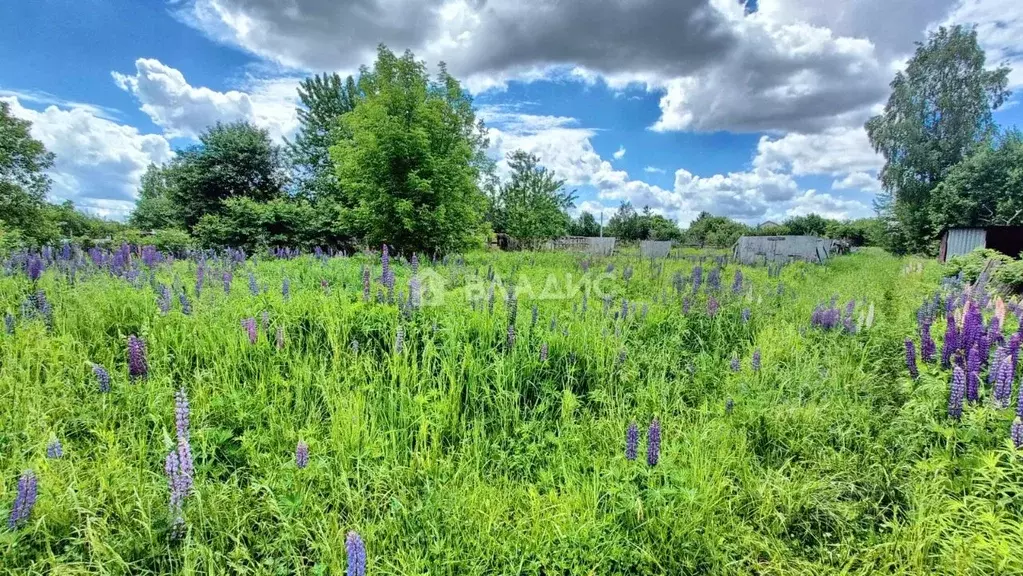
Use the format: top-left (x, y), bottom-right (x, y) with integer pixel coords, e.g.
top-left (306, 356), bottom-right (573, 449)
top-left (287, 74), bottom-right (359, 198)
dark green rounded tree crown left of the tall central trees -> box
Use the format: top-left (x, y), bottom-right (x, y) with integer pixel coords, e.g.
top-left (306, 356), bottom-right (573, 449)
top-left (167, 122), bottom-right (287, 229)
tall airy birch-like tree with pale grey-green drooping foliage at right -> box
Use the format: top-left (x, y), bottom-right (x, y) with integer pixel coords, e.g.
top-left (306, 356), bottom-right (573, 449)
top-left (866, 26), bottom-right (1009, 252)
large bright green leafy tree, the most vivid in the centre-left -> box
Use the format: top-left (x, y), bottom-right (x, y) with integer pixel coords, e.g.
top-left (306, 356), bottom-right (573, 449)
top-left (330, 45), bottom-right (492, 252)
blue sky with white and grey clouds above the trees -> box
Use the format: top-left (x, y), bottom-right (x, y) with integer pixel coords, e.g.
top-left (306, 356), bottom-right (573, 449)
top-left (0, 0), bottom-right (1023, 225)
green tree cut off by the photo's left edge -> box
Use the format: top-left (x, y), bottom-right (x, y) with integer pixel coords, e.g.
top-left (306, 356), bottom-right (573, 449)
top-left (0, 102), bottom-right (54, 243)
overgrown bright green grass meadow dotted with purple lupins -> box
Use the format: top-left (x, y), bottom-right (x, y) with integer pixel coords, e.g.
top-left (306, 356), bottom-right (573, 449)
top-left (0, 251), bottom-right (1023, 575)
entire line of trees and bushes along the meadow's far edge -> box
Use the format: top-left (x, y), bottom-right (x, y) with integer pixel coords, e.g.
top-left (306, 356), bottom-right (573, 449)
top-left (0, 27), bottom-right (1023, 253)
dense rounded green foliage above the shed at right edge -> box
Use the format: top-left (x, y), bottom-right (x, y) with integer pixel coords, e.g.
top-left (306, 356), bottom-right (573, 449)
top-left (930, 131), bottom-right (1023, 230)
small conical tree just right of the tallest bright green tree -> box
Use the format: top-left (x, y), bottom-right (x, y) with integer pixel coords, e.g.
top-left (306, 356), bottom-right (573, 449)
top-left (493, 150), bottom-right (575, 248)
